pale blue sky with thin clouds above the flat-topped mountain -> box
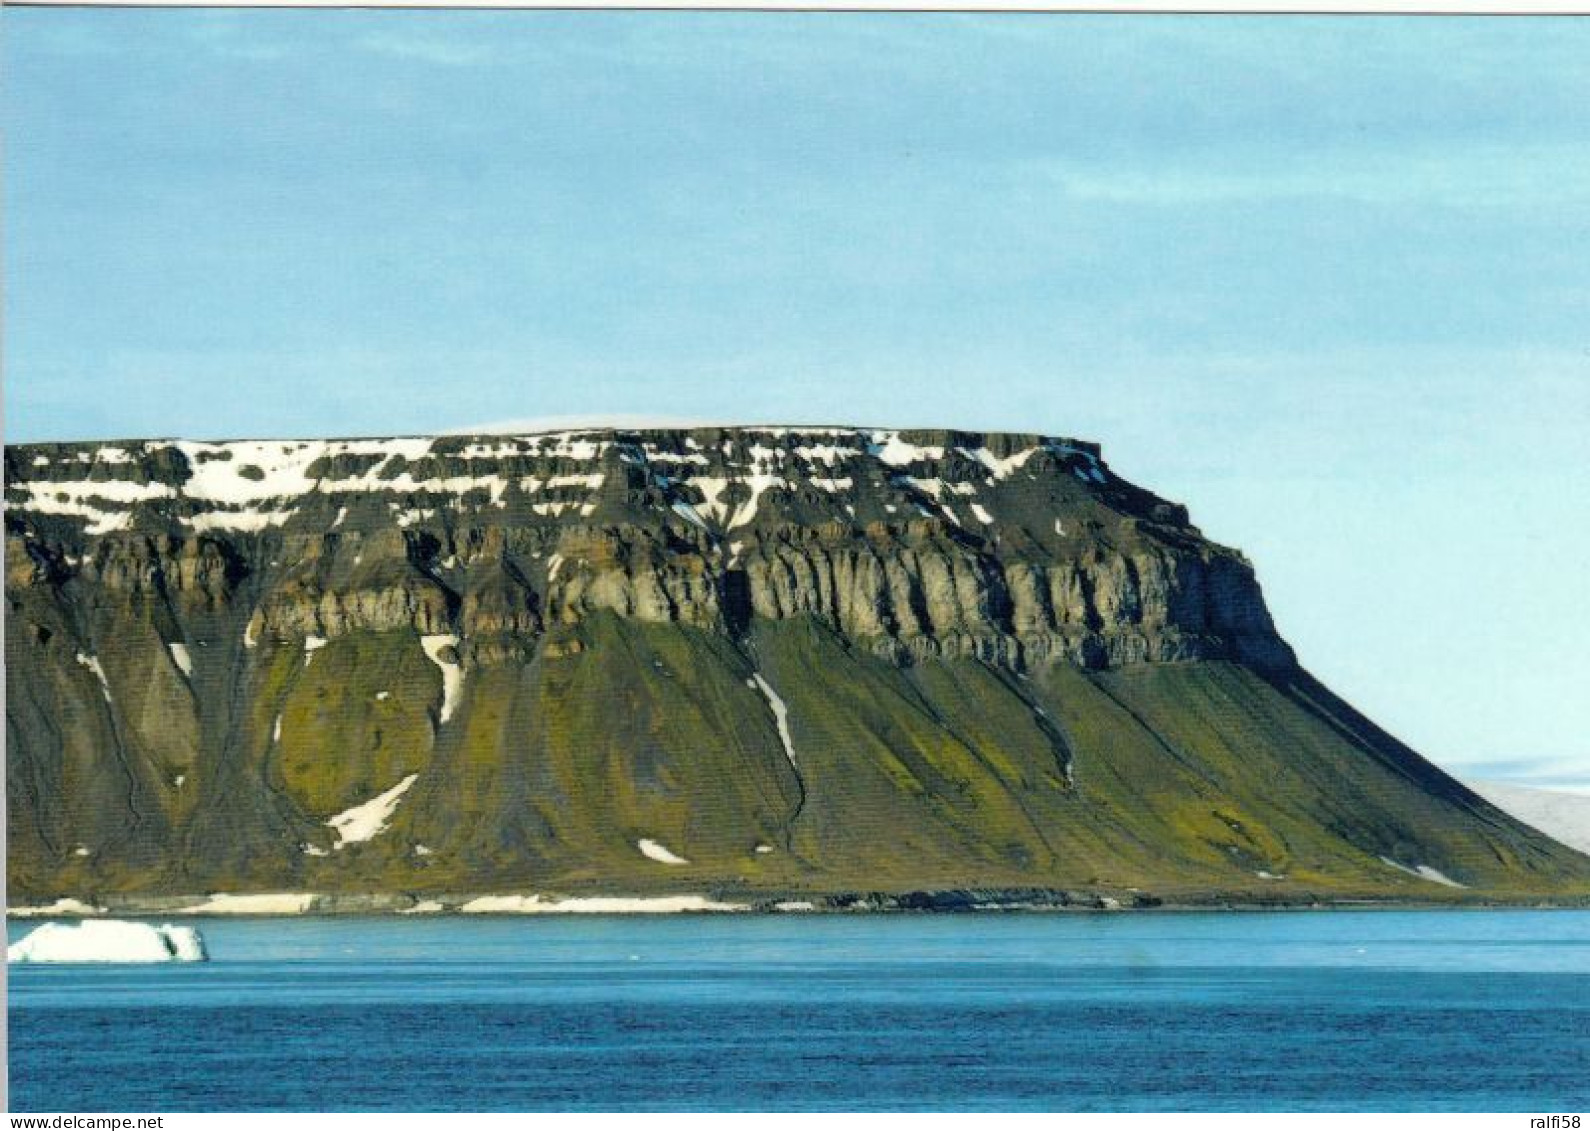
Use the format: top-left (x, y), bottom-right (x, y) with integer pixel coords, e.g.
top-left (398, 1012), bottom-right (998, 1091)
top-left (0, 8), bottom-right (1590, 786)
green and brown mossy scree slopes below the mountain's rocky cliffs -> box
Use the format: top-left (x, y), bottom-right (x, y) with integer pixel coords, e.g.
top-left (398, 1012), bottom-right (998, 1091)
top-left (10, 614), bottom-right (1590, 900)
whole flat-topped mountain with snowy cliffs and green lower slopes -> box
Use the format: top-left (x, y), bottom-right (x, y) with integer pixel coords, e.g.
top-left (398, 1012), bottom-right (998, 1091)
top-left (5, 428), bottom-right (1582, 894)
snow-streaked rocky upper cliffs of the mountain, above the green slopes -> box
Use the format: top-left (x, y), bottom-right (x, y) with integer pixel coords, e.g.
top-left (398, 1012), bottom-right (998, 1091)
top-left (6, 429), bottom-right (1291, 668)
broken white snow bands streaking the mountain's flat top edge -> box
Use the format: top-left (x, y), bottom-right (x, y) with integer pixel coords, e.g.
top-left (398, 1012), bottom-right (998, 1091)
top-left (6, 426), bottom-right (1108, 534)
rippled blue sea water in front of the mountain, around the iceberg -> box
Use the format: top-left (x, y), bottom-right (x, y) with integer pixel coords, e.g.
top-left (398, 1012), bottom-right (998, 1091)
top-left (10, 911), bottom-right (1590, 1112)
